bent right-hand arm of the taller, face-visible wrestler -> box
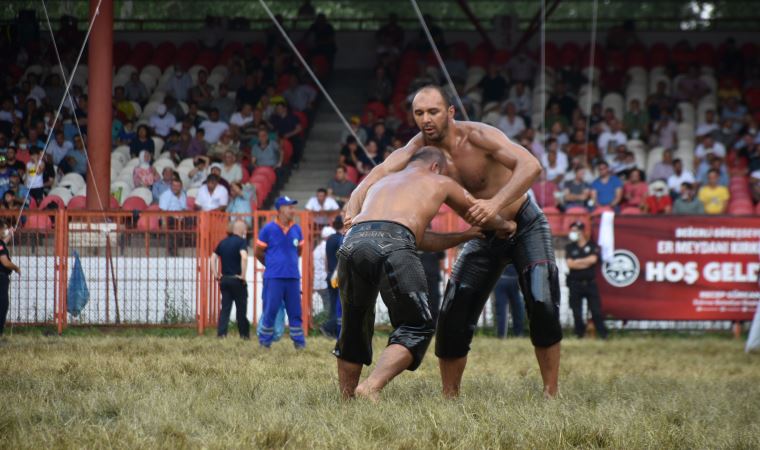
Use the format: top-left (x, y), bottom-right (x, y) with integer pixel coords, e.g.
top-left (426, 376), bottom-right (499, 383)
top-left (465, 126), bottom-right (541, 225)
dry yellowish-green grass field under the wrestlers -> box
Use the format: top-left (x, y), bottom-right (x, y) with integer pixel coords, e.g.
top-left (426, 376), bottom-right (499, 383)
top-left (0, 332), bottom-right (760, 450)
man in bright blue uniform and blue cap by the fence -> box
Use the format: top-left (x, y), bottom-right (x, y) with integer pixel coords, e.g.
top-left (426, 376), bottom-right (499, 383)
top-left (254, 196), bottom-right (306, 349)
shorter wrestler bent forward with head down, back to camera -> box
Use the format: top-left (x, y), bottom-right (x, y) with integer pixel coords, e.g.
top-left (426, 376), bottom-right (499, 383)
top-left (335, 147), bottom-right (515, 400)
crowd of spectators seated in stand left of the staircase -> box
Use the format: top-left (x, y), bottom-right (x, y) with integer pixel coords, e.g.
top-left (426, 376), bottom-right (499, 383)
top-left (0, 15), bottom-right (335, 224)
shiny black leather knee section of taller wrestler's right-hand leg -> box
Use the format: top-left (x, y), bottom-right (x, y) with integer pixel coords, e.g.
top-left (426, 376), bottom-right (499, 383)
top-left (521, 262), bottom-right (562, 347)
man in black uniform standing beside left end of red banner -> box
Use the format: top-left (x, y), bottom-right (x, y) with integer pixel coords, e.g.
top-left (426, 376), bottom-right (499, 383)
top-left (565, 221), bottom-right (607, 339)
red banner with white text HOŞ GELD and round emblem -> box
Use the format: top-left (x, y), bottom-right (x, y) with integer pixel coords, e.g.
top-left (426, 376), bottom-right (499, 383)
top-left (594, 216), bottom-right (760, 320)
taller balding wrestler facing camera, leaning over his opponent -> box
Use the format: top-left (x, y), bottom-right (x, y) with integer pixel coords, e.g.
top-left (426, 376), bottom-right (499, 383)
top-left (346, 86), bottom-right (562, 397)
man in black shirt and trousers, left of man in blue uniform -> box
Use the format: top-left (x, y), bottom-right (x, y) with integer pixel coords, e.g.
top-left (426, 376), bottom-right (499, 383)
top-left (211, 220), bottom-right (251, 339)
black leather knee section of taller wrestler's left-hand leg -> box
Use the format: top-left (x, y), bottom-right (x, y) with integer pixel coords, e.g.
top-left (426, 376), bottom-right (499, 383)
top-left (435, 279), bottom-right (477, 358)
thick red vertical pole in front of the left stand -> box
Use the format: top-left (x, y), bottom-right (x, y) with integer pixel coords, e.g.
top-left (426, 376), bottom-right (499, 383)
top-left (87, 0), bottom-right (113, 210)
